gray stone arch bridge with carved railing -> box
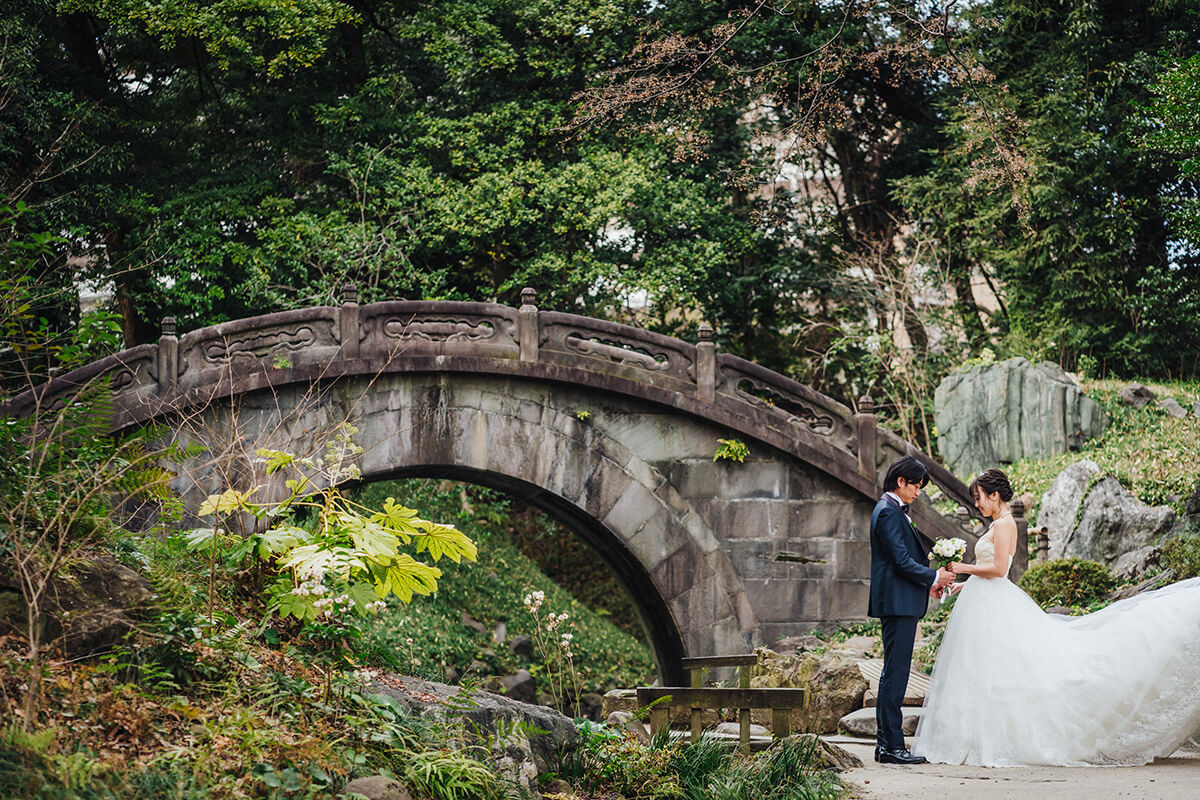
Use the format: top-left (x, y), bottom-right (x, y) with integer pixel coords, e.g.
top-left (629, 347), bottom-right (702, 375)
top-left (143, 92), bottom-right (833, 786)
top-left (7, 287), bottom-right (973, 681)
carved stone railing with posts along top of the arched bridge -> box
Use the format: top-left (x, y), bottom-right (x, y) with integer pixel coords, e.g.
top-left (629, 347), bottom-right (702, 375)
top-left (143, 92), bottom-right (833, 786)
top-left (0, 287), bottom-right (973, 541)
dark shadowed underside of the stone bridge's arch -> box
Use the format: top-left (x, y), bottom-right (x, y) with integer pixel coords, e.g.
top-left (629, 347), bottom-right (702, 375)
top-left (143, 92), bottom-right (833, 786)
top-left (364, 464), bottom-right (685, 686)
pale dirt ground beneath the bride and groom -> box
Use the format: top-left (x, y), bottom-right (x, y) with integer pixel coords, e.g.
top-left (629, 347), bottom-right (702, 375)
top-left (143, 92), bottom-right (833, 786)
top-left (830, 736), bottom-right (1200, 800)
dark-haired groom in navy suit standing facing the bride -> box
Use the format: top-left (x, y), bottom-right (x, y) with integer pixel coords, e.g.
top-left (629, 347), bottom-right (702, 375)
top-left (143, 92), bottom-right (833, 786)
top-left (866, 456), bottom-right (954, 764)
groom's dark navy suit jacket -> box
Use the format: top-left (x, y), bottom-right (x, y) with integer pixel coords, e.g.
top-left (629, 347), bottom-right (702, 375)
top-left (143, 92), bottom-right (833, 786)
top-left (866, 495), bottom-right (937, 616)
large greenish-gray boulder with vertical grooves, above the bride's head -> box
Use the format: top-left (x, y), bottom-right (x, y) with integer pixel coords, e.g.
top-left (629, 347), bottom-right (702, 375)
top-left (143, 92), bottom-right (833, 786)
top-left (934, 357), bottom-right (1109, 475)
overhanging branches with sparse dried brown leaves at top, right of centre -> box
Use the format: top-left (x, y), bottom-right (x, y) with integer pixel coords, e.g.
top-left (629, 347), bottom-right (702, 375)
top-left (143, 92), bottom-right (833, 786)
top-left (569, 0), bottom-right (1031, 215)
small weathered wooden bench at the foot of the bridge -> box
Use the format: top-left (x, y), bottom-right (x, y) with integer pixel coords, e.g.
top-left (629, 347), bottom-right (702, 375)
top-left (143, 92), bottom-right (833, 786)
top-left (637, 654), bottom-right (809, 751)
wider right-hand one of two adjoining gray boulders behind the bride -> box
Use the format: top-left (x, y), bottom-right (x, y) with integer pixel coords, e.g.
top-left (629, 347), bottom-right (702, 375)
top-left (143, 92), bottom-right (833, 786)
top-left (1062, 475), bottom-right (1175, 566)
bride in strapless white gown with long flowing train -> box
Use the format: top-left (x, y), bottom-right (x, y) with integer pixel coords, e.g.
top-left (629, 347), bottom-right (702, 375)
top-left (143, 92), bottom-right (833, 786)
top-left (912, 469), bottom-right (1200, 766)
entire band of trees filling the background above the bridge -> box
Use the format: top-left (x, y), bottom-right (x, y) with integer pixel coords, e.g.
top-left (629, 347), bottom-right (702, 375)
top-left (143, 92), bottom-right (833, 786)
top-left (9, 0), bottom-right (1200, 393)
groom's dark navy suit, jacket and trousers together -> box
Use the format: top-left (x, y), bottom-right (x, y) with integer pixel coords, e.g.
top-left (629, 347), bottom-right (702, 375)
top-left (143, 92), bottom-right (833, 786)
top-left (866, 494), bottom-right (937, 750)
